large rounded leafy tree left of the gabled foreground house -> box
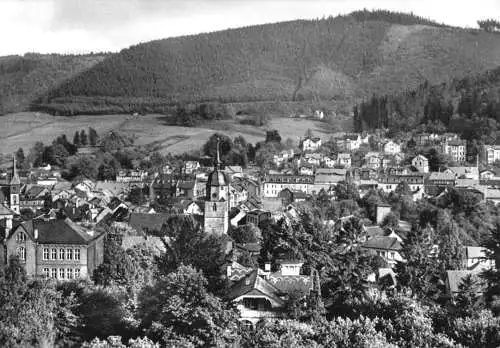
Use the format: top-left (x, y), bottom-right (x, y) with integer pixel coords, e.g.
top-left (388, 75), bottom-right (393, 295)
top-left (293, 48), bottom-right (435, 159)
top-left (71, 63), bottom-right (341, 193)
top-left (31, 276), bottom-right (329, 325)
top-left (138, 265), bottom-right (237, 346)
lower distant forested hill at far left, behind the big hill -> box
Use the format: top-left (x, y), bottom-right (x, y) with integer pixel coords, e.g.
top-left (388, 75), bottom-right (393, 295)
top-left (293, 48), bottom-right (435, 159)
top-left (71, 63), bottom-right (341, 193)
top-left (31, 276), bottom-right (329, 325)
top-left (0, 54), bottom-right (106, 115)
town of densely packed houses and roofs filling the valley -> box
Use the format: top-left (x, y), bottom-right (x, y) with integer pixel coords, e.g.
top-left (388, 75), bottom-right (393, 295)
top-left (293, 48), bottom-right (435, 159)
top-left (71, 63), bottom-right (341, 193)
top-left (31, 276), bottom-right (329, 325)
top-left (0, 121), bottom-right (500, 346)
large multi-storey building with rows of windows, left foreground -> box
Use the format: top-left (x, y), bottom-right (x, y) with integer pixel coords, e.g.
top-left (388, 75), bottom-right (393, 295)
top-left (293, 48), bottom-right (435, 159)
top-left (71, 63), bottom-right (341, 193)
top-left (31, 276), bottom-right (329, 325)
top-left (2, 219), bottom-right (104, 280)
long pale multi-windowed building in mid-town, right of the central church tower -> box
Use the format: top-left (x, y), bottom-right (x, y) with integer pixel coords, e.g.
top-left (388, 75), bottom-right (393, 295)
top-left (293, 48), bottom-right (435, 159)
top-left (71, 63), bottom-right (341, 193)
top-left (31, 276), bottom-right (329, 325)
top-left (262, 174), bottom-right (314, 198)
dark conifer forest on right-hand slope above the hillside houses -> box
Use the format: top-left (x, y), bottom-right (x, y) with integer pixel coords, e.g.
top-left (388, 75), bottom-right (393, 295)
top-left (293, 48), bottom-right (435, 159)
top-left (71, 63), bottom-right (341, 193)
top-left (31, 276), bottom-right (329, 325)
top-left (354, 68), bottom-right (500, 143)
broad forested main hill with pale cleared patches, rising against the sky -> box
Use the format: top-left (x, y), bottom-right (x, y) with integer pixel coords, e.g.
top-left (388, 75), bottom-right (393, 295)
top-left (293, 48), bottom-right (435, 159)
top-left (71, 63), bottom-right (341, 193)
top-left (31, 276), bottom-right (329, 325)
top-left (25, 11), bottom-right (500, 115)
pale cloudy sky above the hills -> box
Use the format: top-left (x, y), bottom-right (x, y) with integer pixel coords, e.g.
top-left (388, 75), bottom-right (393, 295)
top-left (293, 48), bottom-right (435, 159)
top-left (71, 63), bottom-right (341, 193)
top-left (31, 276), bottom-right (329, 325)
top-left (0, 0), bottom-right (500, 56)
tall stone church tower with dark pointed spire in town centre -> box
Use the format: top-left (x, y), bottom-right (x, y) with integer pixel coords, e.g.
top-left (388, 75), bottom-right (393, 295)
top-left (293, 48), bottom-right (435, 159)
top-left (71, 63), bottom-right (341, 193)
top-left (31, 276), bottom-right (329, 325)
top-left (204, 140), bottom-right (230, 235)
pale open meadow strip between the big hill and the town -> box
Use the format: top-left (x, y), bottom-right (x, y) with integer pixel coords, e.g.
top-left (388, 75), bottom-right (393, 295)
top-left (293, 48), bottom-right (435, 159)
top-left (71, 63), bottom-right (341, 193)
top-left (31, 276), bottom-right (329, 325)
top-left (0, 112), bottom-right (352, 158)
